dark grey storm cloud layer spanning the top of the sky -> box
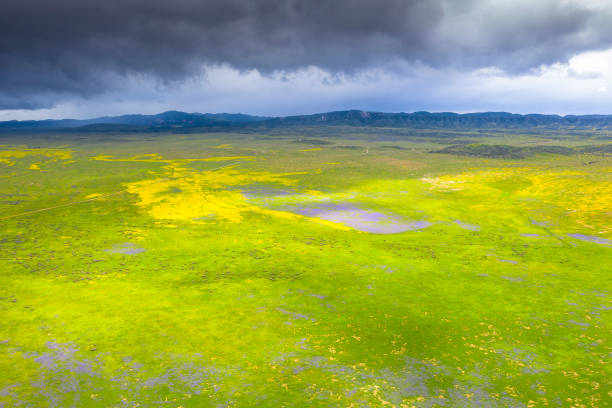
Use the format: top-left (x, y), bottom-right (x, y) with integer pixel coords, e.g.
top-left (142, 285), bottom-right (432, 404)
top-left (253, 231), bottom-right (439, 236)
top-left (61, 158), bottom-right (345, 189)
top-left (0, 0), bottom-right (612, 109)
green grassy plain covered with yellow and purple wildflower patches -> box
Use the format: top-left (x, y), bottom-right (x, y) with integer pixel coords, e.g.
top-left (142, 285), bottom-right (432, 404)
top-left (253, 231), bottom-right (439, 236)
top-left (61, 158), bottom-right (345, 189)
top-left (0, 129), bottom-right (612, 408)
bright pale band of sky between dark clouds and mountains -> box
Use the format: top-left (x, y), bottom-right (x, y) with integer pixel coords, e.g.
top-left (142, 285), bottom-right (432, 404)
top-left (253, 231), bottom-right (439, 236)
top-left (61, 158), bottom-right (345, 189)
top-left (0, 49), bottom-right (612, 120)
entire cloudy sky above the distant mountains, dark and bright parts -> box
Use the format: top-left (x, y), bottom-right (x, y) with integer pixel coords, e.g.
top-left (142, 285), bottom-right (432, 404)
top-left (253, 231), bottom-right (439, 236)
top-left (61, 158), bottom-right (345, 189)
top-left (0, 0), bottom-right (612, 120)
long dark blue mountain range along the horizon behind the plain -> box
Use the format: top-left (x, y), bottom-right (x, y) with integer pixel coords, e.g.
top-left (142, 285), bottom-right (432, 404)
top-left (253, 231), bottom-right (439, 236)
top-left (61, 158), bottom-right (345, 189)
top-left (0, 110), bottom-right (612, 132)
